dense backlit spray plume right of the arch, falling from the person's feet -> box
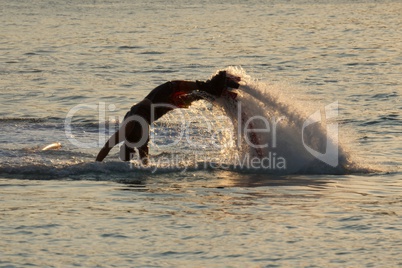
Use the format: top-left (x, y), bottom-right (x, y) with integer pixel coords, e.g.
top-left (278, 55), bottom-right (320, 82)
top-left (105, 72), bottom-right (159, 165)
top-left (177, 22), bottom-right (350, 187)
top-left (209, 67), bottom-right (367, 174)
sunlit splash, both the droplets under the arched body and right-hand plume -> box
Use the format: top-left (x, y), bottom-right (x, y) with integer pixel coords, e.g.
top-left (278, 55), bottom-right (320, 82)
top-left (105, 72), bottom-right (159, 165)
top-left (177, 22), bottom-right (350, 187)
top-left (144, 67), bottom-right (378, 174)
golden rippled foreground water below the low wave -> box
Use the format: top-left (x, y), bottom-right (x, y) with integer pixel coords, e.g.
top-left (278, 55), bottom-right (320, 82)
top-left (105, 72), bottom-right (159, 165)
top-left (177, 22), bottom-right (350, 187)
top-left (0, 172), bottom-right (402, 266)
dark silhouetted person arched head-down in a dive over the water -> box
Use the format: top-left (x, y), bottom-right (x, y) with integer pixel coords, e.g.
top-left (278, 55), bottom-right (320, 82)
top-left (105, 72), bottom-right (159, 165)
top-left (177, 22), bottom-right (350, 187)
top-left (96, 71), bottom-right (240, 165)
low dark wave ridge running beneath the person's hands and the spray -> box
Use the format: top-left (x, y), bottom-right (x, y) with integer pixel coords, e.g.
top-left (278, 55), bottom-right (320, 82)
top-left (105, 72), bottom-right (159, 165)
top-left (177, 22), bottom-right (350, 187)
top-left (0, 155), bottom-right (383, 181)
